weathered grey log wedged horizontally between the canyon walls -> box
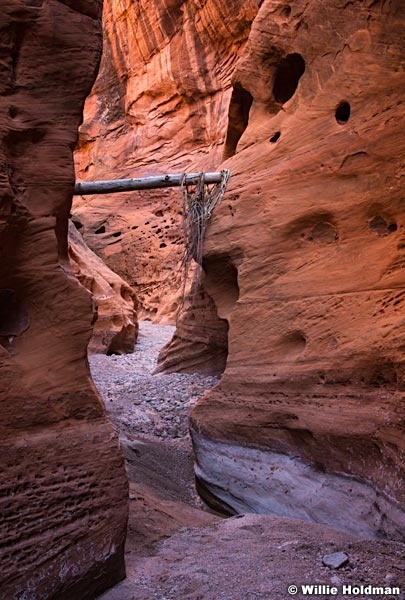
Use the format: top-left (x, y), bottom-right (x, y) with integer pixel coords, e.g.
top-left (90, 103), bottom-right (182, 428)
top-left (74, 171), bottom-right (223, 196)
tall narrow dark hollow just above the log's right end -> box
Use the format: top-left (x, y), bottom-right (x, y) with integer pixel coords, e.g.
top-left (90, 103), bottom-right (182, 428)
top-left (223, 83), bottom-right (253, 160)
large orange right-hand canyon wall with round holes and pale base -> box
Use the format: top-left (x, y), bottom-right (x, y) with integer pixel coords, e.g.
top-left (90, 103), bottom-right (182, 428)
top-left (182, 0), bottom-right (405, 539)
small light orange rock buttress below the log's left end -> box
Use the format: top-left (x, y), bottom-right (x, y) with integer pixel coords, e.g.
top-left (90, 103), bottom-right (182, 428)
top-left (69, 223), bottom-right (138, 354)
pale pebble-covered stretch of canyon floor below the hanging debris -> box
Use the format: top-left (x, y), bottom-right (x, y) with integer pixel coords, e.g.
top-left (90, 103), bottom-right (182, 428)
top-left (89, 321), bottom-right (219, 439)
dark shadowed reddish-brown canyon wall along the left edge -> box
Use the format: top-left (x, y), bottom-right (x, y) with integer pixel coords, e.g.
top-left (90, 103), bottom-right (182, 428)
top-left (0, 0), bottom-right (127, 600)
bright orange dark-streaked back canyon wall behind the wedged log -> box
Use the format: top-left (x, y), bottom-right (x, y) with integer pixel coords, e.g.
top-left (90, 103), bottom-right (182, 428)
top-left (75, 0), bottom-right (257, 320)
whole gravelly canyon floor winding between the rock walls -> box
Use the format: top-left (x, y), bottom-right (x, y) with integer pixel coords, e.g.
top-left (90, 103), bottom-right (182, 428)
top-left (90, 321), bottom-right (405, 600)
